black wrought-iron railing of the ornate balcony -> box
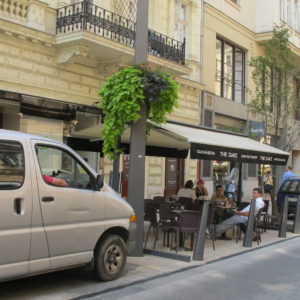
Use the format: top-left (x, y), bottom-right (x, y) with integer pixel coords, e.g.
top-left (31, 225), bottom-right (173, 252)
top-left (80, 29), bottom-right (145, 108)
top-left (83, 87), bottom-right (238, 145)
top-left (56, 1), bottom-right (185, 65)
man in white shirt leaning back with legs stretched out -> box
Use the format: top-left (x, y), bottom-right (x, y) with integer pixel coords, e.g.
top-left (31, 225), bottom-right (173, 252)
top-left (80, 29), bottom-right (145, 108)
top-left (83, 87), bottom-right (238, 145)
top-left (216, 188), bottom-right (265, 237)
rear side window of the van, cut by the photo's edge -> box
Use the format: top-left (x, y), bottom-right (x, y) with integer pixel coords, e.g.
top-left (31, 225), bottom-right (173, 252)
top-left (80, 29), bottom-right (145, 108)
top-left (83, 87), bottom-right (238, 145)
top-left (0, 141), bottom-right (25, 190)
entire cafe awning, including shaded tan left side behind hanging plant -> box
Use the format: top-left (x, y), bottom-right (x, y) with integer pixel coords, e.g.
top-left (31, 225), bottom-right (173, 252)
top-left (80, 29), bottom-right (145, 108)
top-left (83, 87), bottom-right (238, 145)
top-left (72, 122), bottom-right (289, 165)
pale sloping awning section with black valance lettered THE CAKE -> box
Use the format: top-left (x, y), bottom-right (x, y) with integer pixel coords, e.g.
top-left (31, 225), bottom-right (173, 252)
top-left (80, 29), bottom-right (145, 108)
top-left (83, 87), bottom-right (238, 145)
top-left (160, 123), bottom-right (289, 165)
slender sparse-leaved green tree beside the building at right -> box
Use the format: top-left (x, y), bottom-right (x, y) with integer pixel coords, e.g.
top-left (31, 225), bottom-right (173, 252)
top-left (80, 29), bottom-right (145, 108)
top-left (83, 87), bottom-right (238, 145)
top-left (249, 25), bottom-right (300, 214)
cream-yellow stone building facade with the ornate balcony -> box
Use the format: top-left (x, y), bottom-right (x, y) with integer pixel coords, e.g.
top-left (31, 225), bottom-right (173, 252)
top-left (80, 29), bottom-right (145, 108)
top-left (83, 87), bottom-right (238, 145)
top-left (0, 0), bottom-right (202, 197)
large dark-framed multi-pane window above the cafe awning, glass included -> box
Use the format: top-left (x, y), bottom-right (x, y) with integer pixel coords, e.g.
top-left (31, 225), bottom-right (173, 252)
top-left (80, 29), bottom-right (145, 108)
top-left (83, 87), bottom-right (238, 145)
top-left (215, 38), bottom-right (245, 103)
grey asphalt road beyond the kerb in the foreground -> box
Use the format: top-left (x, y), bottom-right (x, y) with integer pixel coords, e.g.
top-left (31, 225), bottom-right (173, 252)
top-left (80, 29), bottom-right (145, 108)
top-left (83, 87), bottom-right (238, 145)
top-left (84, 239), bottom-right (300, 300)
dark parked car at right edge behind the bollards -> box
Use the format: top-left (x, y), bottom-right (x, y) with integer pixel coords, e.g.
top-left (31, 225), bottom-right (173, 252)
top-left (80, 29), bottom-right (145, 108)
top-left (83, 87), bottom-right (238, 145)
top-left (276, 177), bottom-right (300, 216)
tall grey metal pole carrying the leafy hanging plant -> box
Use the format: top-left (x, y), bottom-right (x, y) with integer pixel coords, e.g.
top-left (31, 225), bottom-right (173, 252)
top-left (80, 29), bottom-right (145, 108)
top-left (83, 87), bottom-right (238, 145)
top-left (128, 0), bottom-right (148, 256)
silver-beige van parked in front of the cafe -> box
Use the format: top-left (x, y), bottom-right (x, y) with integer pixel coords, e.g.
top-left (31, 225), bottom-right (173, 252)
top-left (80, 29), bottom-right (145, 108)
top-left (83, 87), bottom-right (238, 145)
top-left (0, 130), bottom-right (136, 281)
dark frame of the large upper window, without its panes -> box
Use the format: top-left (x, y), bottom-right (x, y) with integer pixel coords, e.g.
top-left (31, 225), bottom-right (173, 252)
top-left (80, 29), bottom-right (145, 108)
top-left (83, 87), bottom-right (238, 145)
top-left (215, 36), bottom-right (246, 104)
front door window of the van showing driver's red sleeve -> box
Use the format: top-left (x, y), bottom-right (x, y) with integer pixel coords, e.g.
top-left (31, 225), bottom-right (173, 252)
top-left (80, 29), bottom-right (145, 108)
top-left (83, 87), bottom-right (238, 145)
top-left (35, 145), bottom-right (91, 189)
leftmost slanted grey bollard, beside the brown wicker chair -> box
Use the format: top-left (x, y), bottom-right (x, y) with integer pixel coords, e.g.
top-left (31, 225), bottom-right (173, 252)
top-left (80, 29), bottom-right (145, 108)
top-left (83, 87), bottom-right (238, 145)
top-left (193, 201), bottom-right (209, 260)
